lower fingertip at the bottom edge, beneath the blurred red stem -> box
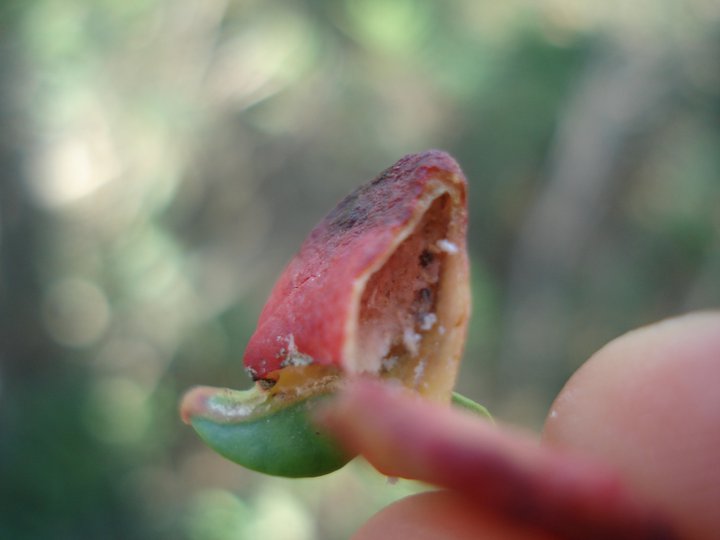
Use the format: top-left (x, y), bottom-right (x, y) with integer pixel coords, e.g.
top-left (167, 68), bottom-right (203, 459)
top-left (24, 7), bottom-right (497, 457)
top-left (353, 491), bottom-right (552, 540)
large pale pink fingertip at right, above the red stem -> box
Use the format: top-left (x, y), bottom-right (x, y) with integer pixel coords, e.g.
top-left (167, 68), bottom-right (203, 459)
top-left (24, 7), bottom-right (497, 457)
top-left (543, 312), bottom-right (720, 538)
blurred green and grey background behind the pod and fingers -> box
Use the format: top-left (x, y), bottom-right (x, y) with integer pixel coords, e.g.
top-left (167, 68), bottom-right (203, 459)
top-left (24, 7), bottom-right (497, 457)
top-left (0, 0), bottom-right (720, 540)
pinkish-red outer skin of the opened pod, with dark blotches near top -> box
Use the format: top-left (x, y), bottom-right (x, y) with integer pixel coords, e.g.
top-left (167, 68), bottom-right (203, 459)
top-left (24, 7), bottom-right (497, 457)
top-left (243, 150), bottom-right (466, 380)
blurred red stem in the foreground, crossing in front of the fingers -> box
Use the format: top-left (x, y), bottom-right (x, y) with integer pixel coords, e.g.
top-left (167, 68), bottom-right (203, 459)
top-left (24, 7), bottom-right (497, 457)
top-left (318, 380), bottom-right (679, 539)
